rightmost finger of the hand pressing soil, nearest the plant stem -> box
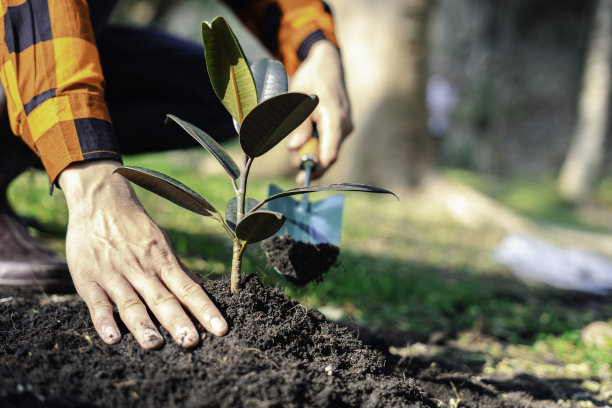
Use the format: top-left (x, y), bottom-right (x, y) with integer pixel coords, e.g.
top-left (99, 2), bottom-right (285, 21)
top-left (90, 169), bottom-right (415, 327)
top-left (162, 262), bottom-right (228, 336)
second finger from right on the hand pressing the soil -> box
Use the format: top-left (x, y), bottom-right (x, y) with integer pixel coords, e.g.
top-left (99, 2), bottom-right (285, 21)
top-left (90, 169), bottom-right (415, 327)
top-left (132, 269), bottom-right (199, 347)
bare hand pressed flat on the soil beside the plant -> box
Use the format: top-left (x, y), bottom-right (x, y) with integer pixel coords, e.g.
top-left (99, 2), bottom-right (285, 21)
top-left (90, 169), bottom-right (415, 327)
top-left (59, 161), bottom-right (227, 349)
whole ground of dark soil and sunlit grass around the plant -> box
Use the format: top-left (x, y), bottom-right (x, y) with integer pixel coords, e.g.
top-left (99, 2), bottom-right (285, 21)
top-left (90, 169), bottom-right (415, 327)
top-left (0, 152), bottom-right (612, 407)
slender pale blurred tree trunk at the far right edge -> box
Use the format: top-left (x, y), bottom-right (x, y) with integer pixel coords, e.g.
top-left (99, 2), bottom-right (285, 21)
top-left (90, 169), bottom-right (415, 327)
top-left (559, 0), bottom-right (612, 203)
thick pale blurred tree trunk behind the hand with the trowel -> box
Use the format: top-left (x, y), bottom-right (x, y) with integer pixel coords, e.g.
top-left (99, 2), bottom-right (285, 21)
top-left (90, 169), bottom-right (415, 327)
top-left (328, 0), bottom-right (433, 187)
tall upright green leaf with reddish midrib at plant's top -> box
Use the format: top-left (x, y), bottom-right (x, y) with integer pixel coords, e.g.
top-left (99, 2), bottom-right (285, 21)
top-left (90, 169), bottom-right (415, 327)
top-left (202, 17), bottom-right (257, 124)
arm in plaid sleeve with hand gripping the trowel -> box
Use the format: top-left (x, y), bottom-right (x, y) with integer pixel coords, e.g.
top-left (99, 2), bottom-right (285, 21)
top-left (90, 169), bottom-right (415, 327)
top-left (226, 0), bottom-right (353, 183)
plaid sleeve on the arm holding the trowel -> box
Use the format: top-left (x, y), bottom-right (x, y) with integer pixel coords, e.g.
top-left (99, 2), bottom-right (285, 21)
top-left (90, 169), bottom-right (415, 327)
top-left (226, 0), bottom-right (338, 75)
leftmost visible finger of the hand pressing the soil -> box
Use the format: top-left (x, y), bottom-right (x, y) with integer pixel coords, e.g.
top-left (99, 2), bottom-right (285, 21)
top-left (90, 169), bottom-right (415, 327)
top-left (78, 282), bottom-right (121, 344)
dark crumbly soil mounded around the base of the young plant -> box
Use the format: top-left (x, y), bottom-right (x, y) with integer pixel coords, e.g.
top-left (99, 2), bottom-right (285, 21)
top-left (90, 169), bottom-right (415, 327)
top-left (0, 275), bottom-right (592, 407)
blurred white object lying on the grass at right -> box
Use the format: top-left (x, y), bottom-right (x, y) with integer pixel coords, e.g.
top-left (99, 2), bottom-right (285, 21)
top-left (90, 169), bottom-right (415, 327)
top-left (493, 234), bottom-right (612, 295)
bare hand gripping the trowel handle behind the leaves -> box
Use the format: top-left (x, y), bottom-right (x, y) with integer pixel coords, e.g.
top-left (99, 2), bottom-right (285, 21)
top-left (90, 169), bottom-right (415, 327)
top-left (288, 41), bottom-right (353, 184)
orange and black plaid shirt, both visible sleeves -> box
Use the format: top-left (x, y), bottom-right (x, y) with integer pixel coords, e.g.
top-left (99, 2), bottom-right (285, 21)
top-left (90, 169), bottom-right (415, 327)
top-left (0, 0), bottom-right (337, 182)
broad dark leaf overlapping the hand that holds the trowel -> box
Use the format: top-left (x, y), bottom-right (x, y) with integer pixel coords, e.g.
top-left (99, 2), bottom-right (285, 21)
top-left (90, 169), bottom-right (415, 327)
top-left (240, 92), bottom-right (319, 158)
